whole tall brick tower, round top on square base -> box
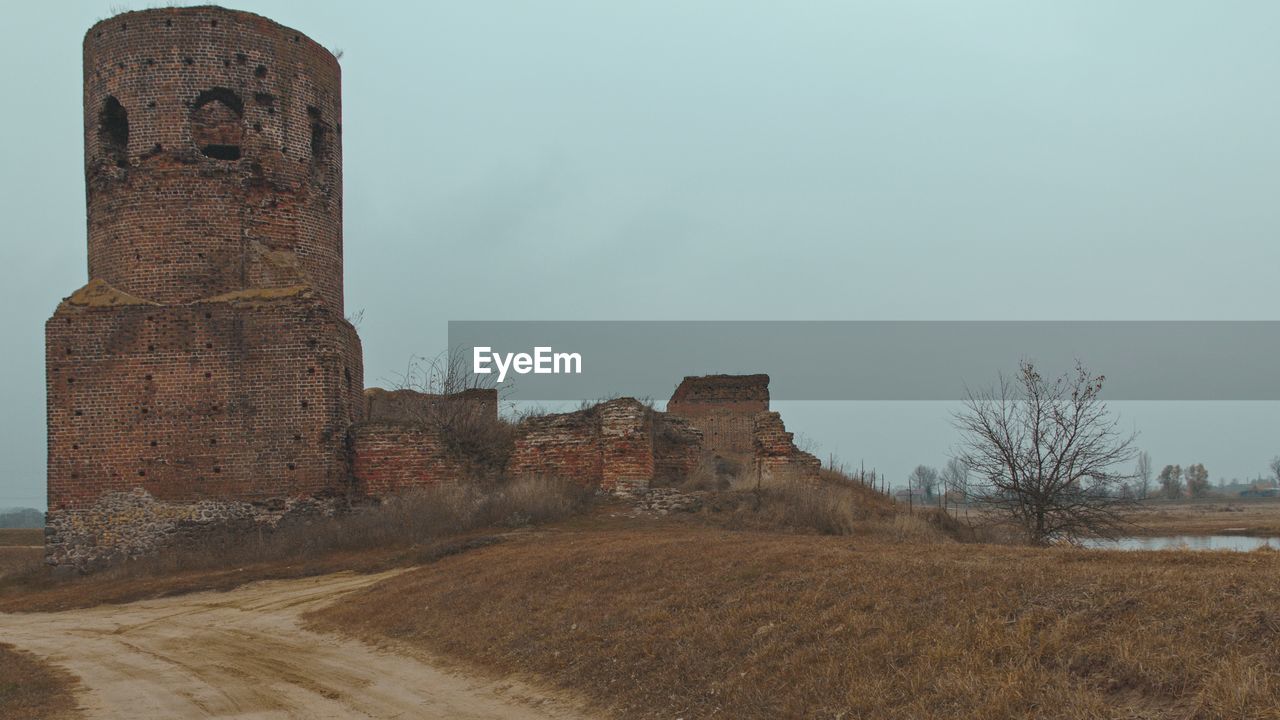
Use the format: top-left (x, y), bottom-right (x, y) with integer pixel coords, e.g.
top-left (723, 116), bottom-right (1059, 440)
top-left (45, 6), bottom-right (364, 564)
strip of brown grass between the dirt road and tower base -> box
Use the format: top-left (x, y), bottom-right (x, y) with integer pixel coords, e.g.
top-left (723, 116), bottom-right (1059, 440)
top-left (0, 478), bottom-right (588, 612)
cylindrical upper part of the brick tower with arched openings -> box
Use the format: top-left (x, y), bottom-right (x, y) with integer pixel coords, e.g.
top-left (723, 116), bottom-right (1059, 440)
top-left (84, 6), bottom-right (343, 314)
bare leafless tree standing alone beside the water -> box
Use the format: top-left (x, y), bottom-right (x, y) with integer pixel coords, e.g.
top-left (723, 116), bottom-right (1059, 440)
top-left (954, 360), bottom-right (1137, 544)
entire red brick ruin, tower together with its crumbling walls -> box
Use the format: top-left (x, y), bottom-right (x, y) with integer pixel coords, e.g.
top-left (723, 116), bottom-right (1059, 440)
top-left (45, 6), bottom-right (817, 568)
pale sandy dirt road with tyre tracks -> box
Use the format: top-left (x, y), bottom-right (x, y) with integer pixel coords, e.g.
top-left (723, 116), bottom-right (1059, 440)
top-left (0, 573), bottom-right (584, 720)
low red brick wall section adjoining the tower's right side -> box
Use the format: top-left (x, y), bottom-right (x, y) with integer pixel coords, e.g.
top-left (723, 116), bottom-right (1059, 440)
top-left (351, 420), bottom-right (467, 497)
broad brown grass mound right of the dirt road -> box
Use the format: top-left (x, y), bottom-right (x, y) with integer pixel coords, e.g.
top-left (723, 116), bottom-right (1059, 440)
top-left (312, 520), bottom-right (1280, 720)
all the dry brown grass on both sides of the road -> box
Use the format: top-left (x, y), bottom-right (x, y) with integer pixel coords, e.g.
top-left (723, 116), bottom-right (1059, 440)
top-left (0, 478), bottom-right (1280, 720)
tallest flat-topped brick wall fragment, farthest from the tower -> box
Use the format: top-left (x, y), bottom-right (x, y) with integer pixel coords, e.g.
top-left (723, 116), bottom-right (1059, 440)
top-left (667, 374), bottom-right (769, 456)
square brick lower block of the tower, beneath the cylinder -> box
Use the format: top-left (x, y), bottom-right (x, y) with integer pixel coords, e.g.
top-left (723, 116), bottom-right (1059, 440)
top-left (45, 282), bottom-right (364, 512)
